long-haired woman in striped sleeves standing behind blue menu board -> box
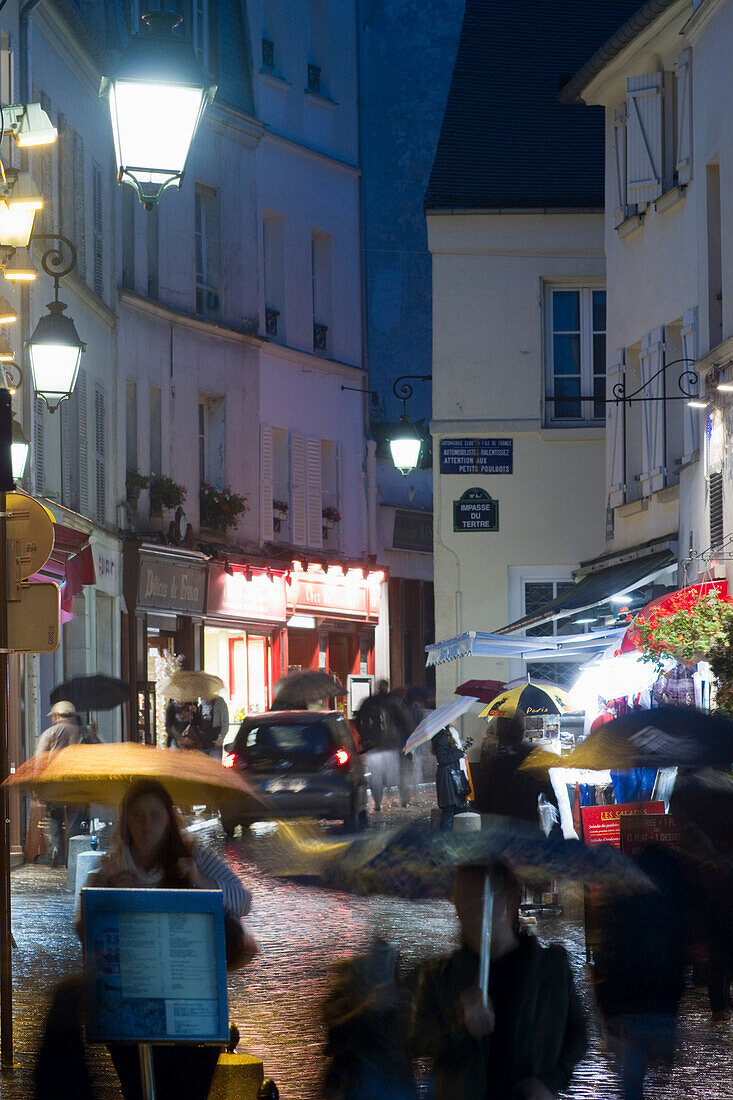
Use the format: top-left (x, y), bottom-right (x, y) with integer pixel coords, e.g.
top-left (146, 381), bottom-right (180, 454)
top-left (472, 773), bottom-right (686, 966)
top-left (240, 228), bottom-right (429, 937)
top-left (87, 780), bottom-right (250, 1100)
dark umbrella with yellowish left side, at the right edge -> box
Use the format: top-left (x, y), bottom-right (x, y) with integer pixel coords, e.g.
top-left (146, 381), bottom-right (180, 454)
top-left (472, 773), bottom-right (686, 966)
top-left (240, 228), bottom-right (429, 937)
top-left (567, 706), bottom-right (733, 770)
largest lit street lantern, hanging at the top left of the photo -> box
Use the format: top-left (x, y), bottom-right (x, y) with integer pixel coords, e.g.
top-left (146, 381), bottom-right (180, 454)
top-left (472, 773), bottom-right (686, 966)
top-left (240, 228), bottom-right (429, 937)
top-left (99, 11), bottom-right (217, 210)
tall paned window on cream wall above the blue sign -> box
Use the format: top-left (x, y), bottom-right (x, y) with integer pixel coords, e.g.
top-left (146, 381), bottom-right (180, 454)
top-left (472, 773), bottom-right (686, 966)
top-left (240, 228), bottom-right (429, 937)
top-left (547, 287), bottom-right (605, 424)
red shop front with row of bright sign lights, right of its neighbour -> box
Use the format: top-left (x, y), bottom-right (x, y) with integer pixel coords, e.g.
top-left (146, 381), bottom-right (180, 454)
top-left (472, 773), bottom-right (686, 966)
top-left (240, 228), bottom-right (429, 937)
top-left (286, 563), bottom-right (384, 716)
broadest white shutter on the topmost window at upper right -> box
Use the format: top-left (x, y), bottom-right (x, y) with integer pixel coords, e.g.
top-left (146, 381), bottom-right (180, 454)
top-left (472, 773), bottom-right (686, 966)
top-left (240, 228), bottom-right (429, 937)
top-left (626, 73), bottom-right (664, 205)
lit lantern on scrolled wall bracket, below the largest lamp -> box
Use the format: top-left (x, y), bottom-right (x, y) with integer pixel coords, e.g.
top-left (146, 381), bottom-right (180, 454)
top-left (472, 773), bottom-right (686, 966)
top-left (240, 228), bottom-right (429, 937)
top-left (28, 234), bottom-right (87, 413)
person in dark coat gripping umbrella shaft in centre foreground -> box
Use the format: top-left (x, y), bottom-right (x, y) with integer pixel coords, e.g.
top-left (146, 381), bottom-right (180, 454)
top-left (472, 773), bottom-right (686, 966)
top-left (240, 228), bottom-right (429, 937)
top-left (411, 865), bottom-right (587, 1100)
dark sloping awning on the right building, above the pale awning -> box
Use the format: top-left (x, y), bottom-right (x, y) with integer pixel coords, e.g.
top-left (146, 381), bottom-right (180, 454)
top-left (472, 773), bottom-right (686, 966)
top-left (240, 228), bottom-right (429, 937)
top-left (495, 549), bottom-right (677, 635)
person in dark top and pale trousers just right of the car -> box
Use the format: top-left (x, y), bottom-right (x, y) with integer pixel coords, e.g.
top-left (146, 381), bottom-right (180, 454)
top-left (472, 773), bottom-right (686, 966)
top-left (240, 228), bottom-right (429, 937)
top-left (354, 680), bottom-right (409, 813)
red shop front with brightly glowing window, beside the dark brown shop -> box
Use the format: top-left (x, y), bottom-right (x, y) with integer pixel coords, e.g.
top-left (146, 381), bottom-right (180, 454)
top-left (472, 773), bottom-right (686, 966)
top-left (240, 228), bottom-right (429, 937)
top-left (204, 562), bottom-right (286, 721)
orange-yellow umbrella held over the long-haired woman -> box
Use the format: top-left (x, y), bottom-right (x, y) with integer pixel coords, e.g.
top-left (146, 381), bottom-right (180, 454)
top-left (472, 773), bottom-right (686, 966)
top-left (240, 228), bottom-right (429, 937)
top-left (3, 741), bottom-right (255, 806)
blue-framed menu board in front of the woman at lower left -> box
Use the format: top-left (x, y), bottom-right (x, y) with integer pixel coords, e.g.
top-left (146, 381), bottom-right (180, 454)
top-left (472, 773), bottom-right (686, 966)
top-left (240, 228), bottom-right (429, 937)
top-left (81, 888), bottom-right (229, 1043)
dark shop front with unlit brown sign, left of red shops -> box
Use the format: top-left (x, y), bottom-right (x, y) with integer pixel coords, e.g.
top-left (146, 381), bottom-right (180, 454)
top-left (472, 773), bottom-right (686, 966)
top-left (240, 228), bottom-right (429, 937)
top-left (122, 542), bottom-right (208, 745)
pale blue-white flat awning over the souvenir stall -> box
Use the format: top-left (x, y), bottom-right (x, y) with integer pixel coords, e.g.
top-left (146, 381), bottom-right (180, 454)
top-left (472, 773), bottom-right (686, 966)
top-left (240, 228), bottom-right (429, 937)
top-left (425, 627), bottom-right (625, 667)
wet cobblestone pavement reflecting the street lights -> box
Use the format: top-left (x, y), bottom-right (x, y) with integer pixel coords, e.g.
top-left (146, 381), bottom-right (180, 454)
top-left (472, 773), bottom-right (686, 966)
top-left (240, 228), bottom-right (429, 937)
top-left (0, 800), bottom-right (733, 1100)
